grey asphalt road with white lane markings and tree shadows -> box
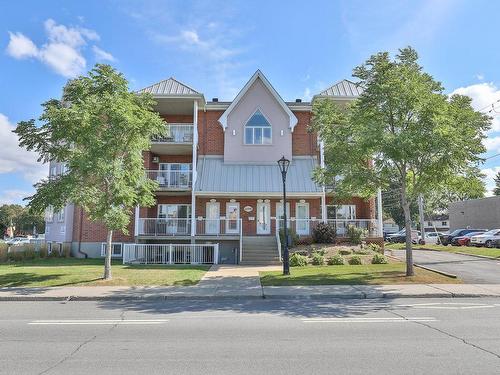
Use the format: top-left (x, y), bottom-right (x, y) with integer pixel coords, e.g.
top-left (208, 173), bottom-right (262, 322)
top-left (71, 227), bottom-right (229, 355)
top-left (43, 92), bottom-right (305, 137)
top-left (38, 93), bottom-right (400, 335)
top-left (0, 298), bottom-right (500, 375)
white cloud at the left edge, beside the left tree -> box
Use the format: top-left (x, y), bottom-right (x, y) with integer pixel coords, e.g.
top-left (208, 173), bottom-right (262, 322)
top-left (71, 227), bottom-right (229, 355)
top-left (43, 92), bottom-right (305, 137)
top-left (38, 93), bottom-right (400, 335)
top-left (0, 113), bottom-right (47, 183)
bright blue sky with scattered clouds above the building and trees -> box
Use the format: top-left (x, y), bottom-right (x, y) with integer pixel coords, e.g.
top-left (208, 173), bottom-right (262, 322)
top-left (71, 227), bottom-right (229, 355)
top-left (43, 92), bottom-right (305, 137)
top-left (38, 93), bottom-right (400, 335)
top-left (0, 0), bottom-right (500, 204)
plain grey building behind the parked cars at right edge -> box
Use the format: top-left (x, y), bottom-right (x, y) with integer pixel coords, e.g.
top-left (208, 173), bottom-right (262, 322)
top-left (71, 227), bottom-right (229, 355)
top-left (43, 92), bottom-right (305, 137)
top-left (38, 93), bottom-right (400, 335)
top-left (448, 196), bottom-right (500, 231)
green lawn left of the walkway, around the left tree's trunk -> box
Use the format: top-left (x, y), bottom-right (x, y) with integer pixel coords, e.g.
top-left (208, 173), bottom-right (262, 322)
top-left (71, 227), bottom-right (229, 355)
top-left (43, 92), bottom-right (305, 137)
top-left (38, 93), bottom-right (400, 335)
top-left (0, 258), bottom-right (210, 287)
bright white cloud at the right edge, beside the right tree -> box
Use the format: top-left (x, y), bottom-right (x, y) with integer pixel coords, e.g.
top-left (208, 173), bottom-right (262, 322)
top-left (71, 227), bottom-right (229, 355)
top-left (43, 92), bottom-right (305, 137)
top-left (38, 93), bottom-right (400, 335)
top-left (451, 82), bottom-right (500, 132)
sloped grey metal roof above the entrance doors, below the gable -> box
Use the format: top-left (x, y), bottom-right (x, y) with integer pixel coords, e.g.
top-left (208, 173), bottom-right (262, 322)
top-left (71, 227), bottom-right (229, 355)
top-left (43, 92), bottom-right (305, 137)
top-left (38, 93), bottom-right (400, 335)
top-left (196, 157), bottom-right (321, 193)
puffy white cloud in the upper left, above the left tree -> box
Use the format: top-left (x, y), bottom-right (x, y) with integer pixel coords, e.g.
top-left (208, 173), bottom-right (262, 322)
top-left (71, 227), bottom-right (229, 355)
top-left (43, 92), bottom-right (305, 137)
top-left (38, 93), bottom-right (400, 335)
top-left (6, 18), bottom-right (110, 78)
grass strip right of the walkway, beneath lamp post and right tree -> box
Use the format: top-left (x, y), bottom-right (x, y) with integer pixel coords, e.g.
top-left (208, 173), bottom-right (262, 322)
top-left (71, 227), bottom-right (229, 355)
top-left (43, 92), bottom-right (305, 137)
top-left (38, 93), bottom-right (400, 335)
top-left (260, 262), bottom-right (460, 286)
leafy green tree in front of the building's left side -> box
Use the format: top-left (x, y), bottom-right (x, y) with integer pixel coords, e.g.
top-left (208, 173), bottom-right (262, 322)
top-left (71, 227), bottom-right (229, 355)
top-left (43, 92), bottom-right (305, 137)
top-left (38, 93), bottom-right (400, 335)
top-left (15, 64), bottom-right (165, 279)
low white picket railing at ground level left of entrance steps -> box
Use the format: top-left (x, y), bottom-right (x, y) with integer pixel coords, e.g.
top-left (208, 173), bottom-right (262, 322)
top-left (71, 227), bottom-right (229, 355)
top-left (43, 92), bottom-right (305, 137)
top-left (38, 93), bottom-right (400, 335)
top-left (123, 243), bottom-right (219, 264)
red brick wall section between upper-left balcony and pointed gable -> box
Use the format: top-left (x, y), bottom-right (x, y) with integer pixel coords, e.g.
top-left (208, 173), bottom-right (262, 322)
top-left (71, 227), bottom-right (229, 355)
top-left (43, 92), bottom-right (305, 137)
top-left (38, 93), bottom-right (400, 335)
top-left (198, 111), bottom-right (224, 155)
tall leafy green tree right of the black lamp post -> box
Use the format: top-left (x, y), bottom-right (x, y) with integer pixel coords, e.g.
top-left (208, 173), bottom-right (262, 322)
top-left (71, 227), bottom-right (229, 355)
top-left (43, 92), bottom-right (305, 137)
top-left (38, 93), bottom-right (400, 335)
top-left (312, 47), bottom-right (491, 276)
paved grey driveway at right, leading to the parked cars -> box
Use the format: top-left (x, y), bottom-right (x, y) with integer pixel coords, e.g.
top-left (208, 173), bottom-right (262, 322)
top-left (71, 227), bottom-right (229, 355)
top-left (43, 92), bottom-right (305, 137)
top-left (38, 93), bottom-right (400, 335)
top-left (393, 250), bottom-right (500, 284)
